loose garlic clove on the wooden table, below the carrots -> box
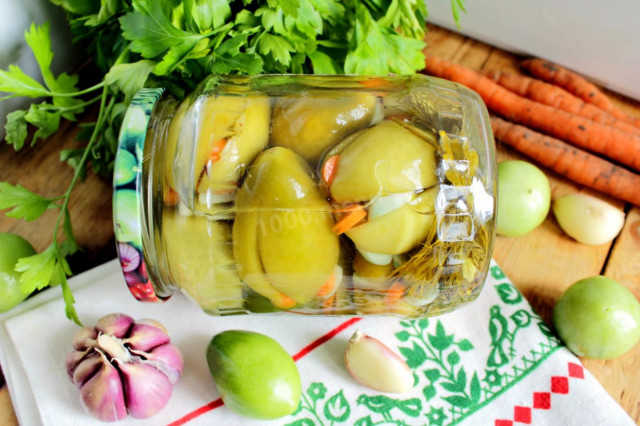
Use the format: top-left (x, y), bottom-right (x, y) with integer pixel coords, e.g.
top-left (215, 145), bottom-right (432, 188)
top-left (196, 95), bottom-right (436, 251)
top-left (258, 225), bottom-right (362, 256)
top-left (553, 193), bottom-right (624, 244)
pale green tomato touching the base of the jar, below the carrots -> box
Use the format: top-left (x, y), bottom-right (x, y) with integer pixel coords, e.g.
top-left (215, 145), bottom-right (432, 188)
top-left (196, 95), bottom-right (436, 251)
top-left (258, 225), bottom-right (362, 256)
top-left (496, 160), bottom-right (551, 237)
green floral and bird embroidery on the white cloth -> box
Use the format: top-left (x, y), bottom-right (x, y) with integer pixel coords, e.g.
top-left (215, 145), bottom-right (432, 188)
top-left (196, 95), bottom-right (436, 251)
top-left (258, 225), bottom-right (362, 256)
top-left (288, 266), bottom-right (560, 426)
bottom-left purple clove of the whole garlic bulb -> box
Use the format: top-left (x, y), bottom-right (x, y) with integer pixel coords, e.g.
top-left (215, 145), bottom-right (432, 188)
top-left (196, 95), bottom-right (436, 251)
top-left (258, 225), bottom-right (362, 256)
top-left (80, 356), bottom-right (127, 422)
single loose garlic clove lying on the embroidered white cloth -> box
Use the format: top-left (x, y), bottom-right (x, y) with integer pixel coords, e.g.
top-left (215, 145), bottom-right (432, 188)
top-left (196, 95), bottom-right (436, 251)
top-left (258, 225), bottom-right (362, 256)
top-left (345, 330), bottom-right (413, 393)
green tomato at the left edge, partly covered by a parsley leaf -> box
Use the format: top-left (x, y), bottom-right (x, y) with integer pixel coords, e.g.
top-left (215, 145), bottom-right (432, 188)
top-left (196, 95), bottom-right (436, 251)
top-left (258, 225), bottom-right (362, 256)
top-left (0, 232), bottom-right (36, 312)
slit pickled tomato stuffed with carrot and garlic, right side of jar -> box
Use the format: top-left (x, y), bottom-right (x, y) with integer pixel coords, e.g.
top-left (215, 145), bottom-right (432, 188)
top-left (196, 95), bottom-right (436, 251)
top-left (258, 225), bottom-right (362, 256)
top-left (322, 120), bottom-right (438, 261)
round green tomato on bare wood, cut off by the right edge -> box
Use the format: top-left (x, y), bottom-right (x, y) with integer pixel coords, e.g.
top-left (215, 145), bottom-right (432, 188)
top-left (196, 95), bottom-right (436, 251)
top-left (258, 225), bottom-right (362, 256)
top-left (553, 276), bottom-right (640, 359)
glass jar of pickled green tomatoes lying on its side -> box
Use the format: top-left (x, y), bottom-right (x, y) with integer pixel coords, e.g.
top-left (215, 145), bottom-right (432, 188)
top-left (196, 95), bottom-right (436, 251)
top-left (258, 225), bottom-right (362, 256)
top-left (114, 75), bottom-right (496, 318)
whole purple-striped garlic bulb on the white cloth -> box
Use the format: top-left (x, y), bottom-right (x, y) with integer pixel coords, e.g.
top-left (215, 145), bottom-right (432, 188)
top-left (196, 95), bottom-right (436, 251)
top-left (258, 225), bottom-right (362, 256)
top-left (66, 313), bottom-right (184, 422)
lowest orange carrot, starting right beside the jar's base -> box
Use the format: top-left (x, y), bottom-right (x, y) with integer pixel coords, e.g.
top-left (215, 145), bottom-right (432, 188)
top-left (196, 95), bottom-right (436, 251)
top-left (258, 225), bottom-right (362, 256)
top-left (491, 116), bottom-right (640, 206)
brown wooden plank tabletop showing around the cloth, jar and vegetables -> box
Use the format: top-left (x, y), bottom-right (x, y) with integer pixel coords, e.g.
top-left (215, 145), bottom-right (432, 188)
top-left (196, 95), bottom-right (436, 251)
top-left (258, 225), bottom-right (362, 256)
top-left (0, 26), bottom-right (640, 425)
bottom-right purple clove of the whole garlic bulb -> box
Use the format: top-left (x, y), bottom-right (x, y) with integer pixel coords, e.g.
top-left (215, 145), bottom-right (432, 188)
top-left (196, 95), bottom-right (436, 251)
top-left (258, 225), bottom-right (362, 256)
top-left (116, 360), bottom-right (172, 419)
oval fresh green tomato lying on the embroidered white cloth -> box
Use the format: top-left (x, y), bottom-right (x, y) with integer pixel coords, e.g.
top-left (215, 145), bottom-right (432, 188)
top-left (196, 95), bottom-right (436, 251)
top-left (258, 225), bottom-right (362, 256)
top-left (207, 330), bottom-right (302, 419)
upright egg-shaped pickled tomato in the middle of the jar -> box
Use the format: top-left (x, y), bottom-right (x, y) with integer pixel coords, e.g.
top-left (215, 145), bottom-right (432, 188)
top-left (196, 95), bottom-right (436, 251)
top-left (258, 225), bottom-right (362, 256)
top-left (232, 147), bottom-right (340, 309)
